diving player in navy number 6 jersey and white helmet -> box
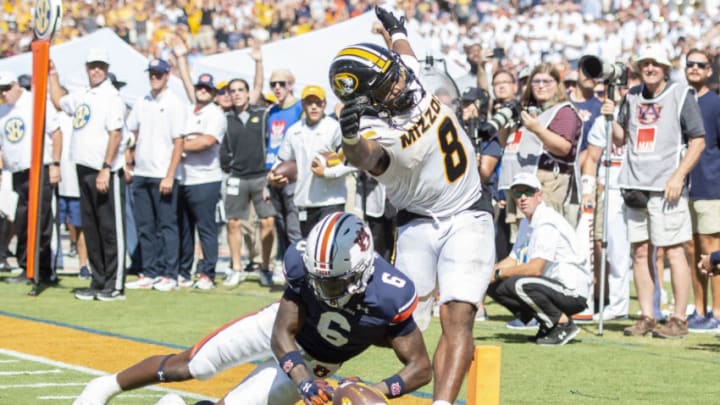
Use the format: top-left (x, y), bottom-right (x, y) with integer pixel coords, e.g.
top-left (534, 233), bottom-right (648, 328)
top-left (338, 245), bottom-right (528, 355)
top-left (74, 212), bottom-right (432, 405)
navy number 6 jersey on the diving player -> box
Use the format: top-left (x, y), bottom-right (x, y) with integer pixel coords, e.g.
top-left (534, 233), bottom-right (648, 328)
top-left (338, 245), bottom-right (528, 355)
top-left (283, 242), bottom-right (418, 363)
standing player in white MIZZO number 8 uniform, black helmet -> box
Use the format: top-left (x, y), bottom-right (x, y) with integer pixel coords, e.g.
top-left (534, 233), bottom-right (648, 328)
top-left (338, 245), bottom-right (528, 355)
top-left (329, 7), bottom-right (495, 405)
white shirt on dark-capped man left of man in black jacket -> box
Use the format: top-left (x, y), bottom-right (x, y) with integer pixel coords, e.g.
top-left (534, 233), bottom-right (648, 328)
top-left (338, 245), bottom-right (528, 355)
top-left (180, 103), bottom-right (227, 186)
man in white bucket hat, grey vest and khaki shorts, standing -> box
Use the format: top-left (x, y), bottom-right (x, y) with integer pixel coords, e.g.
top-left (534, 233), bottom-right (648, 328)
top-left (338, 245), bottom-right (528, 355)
top-left (603, 44), bottom-right (705, 338)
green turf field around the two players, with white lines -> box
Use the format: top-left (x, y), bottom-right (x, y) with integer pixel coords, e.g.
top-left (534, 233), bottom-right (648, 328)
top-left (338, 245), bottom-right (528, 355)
top-left (0, 276), bottom-right (720, 404)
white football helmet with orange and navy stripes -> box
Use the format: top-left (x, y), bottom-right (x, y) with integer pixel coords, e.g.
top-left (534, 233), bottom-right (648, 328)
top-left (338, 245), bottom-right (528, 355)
top-left (303, 212), bottom-right (375, 307)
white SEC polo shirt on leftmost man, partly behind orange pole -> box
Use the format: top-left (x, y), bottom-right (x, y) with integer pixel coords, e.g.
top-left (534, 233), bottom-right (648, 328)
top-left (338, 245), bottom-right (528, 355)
top-left (0, 89), bottom-right (59, 173)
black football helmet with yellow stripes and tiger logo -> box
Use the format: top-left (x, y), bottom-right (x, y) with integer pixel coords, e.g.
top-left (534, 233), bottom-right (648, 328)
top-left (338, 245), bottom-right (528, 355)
top-left (329, 43), bottom-right (415, 113)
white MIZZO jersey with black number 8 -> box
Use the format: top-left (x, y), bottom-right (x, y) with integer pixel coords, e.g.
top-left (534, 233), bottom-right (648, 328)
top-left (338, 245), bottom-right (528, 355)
top-left (361, 95), bottom-right (482, 217)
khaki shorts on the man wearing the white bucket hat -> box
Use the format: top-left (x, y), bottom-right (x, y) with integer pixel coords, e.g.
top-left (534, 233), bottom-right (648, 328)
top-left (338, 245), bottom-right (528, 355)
top-left (625, 191), bottom-right (692, 247)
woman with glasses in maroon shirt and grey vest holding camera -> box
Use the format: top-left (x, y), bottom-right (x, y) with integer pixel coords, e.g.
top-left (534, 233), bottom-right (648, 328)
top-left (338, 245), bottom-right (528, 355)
top-left (498, 63), bottom-right (582, 227)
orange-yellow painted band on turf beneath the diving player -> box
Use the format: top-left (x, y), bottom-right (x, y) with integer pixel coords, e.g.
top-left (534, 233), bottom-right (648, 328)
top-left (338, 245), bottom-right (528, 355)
top-left (0, 315), bottom-right (431, 405)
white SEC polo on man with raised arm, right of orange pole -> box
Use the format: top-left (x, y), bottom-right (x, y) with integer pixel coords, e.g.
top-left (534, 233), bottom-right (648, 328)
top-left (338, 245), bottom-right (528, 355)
top-left (60, 80), bottom-right (125, 171)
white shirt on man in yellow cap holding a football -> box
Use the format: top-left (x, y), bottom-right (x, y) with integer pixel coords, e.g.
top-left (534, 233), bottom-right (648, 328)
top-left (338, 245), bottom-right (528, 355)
top-left (278, 117), bottom-right (357, 207)
